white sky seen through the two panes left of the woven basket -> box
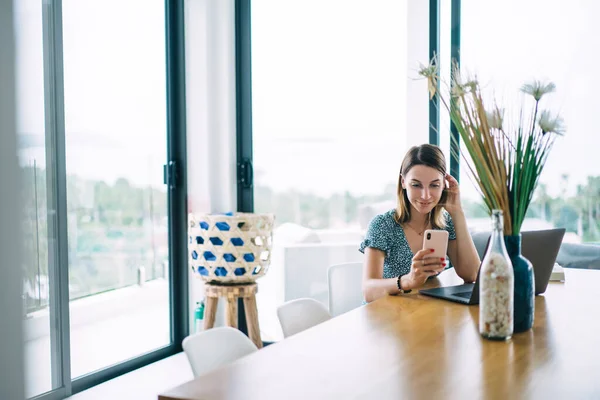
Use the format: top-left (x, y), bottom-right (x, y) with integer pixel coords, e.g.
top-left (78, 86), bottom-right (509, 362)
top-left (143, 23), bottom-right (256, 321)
top-left (15, 0), bottom-right (167, 187)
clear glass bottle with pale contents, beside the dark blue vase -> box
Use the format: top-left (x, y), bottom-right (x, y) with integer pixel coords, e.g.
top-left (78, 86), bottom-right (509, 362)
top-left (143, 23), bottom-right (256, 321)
top-left (479, 210), bottom-right (515, 340)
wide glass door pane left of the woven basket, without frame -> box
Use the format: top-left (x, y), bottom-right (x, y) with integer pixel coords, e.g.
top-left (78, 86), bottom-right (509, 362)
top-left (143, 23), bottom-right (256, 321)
top-left (63, 0), bottom-right (171, 378)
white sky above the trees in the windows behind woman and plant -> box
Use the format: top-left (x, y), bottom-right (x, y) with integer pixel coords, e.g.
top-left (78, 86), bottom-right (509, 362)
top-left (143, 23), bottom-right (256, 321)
top-left (252, 0), bottom-right (600, 198)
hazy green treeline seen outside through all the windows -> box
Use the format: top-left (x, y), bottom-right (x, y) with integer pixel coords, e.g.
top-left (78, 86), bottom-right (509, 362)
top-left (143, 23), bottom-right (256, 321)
top-left (22, 162), bottom-right (600, 309)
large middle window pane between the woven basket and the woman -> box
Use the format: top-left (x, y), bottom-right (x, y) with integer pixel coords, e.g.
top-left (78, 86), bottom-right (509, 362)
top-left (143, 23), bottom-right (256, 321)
top-left (251, 0), bottom-right (428, 340)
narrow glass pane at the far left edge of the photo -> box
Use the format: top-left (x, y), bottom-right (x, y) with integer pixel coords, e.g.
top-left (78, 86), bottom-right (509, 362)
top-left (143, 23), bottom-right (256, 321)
top-left (14, 0), bottom-right (60, 397)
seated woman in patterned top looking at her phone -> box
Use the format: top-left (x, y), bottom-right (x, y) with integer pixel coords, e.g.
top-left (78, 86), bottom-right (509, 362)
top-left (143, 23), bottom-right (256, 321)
top-left (359, 144), bottom-right (480, 302)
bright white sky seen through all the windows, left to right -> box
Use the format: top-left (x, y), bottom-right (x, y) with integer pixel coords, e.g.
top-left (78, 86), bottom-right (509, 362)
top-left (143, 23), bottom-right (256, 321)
top-left (16, 0), bottom-right (600, 197)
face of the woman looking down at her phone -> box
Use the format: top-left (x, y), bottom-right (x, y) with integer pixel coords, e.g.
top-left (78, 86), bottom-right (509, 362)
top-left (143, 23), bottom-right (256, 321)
top-left (402, 165), bottom-right (445, 214)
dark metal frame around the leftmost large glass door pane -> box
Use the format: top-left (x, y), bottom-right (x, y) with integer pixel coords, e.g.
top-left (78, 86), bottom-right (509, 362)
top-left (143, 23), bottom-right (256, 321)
top-left (32, 0), bottom-right (189, 400)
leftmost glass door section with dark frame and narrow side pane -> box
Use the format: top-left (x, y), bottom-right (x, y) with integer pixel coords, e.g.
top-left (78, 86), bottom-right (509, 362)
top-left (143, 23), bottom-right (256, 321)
top-left (15, 0), bottom-right (187, 399)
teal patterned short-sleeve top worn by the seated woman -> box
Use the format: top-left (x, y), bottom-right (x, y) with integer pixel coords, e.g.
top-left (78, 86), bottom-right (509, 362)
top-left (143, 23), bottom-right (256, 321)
top-left (359, 209), bottom-right (456, 279)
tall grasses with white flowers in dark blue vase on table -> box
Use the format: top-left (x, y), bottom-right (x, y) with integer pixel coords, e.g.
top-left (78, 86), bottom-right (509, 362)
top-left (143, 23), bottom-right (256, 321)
top-left (419, 57), bottom-right (564, 333)
